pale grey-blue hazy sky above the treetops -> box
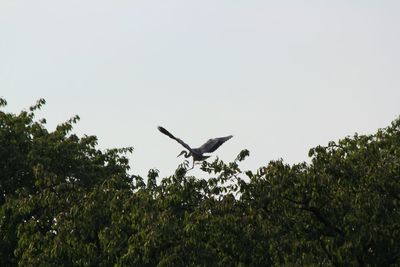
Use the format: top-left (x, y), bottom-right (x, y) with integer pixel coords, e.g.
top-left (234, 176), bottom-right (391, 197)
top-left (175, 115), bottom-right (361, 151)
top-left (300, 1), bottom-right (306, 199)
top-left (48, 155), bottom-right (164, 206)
top-left (0, 0), bottom-right (400, 179)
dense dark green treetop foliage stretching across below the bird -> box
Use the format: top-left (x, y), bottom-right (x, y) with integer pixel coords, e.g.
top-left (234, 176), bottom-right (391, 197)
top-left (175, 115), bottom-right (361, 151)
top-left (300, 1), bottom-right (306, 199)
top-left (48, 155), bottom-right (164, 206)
top-left (0, 99), bottom-right (400, 266)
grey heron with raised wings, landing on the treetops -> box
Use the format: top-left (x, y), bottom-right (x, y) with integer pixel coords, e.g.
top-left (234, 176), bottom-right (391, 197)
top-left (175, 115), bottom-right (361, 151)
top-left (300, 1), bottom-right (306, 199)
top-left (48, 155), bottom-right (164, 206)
top-left (157, 126), bottom-right (233, 169)
